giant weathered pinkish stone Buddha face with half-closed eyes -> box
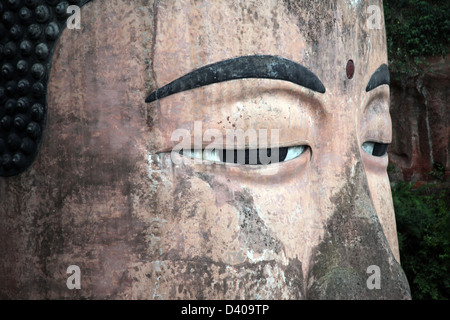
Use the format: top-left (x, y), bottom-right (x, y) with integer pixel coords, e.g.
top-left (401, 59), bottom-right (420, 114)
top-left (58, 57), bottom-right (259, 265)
top-left (0, 0), bottom-right (410, 299)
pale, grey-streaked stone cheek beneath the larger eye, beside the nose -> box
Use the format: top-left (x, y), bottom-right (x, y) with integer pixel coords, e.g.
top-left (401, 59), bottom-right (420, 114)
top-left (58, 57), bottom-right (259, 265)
top-left (151, 150), bottom-right (317, 265)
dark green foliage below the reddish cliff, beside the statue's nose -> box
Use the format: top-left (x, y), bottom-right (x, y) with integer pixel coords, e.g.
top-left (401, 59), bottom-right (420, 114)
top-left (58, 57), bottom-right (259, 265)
top-left (392, 182), bottom-right (450, 300)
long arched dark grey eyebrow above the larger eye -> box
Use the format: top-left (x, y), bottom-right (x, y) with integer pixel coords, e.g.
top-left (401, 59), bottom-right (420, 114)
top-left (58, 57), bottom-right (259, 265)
top-left (145, 55), bottom-right (325, 103)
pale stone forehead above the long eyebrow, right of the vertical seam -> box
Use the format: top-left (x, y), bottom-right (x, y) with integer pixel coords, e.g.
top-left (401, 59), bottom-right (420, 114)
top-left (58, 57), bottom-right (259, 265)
top-left (153, 0), bottom-right (386, 94)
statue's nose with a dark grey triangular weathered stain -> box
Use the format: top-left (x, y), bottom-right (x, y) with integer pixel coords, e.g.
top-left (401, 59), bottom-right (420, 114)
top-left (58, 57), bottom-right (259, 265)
top-left (306, 155), bottom-right (411, 299)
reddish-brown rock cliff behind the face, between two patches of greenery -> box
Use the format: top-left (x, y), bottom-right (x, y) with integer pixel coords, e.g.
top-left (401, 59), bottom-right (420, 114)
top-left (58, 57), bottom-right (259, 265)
top-left (389, 55), bottom-right (450, 181)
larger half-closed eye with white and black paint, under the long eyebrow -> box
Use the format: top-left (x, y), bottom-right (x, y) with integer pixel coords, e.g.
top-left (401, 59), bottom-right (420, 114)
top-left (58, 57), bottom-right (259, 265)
top-left (180, 145), bottom-right (308, 165)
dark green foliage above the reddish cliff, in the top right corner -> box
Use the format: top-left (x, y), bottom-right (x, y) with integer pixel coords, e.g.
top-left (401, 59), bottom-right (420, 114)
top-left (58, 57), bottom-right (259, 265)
top-left (383, 0), bottom-right (450, 76)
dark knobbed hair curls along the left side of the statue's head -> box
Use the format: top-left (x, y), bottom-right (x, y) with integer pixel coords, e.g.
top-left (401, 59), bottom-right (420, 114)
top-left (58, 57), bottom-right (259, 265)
top-left (0, 0), bottom-right (89, 177)
